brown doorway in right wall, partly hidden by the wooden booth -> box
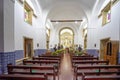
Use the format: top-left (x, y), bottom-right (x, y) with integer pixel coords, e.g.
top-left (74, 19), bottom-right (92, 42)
top-left (100, 38), bottom-right (110, 60)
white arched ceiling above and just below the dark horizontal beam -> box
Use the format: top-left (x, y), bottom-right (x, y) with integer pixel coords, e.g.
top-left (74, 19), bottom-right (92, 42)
top-left (38, 0), bottom-right (97, 27)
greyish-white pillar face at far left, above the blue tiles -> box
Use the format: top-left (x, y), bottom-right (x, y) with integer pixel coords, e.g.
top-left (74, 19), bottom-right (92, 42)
top-left (4, 0), bottom-right (14, 52)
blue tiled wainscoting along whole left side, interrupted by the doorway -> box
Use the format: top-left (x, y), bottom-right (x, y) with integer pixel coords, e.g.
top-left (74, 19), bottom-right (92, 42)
top-left (0, 49), bottom-right (46, 74)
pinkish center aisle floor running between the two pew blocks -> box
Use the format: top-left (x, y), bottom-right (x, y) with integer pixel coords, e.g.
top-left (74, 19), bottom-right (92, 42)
top-left (59, 53), bottom-right (73, 80)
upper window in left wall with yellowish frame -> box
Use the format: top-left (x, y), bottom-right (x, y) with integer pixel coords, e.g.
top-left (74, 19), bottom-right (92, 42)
top-left (24, 1), bottom-right (33, 25)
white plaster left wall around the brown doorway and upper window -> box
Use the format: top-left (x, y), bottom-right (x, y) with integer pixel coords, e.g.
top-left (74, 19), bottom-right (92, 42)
top-left (15, 1), bottom-right (46, 50)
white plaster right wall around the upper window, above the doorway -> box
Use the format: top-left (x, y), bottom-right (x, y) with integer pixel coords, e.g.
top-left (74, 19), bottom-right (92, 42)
top-left (87, 1), bottom-right (120, 49)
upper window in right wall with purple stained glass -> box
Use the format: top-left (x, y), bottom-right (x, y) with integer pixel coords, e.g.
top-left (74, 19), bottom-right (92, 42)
top-left (102, 2), bottom-right (111, 25)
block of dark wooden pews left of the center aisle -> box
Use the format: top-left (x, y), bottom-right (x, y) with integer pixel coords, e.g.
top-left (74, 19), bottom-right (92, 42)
top-left (0, 56), bottom-right (61, 80)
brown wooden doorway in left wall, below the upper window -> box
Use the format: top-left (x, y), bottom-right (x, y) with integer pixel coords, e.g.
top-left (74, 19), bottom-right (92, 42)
top-left (24, 37), bottom-right (33, 58)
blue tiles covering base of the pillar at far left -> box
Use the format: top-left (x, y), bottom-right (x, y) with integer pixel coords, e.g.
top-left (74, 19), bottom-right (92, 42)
top-left (0, 52), bottom-right (15, 74)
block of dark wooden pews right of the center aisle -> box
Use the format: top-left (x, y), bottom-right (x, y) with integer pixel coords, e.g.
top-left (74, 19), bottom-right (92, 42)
top-left (71, 56), bottom-right (120, 80)
